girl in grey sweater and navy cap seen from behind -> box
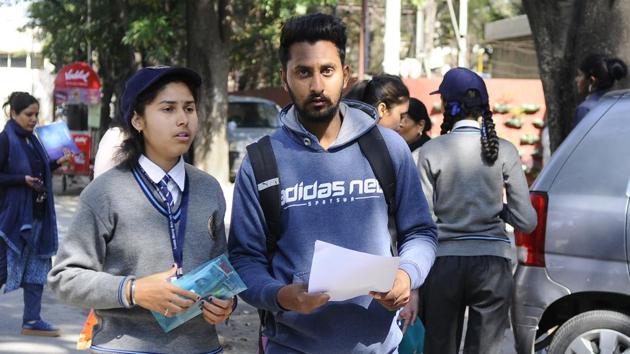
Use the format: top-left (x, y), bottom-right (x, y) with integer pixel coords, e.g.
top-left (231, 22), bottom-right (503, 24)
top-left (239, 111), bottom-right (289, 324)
top-left (418, 68), bottom-right (536, 354)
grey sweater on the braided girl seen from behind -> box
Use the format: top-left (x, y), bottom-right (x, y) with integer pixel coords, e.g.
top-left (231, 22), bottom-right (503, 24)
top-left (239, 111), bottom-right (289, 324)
top-left (419, 120), bottom-right (536, 258)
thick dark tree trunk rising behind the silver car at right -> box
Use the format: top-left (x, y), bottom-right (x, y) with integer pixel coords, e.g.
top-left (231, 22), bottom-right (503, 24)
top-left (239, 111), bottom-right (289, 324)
top-left (523, 0), bottom-right (630, 151)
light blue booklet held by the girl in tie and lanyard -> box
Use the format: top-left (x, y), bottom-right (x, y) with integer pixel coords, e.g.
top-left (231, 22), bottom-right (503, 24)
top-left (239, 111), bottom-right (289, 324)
top-left (152, 254), bottom-right (247, 332)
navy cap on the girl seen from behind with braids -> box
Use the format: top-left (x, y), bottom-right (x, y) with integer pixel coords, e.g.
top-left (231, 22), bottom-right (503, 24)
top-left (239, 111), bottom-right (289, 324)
top-left (431, 68), bottom-right (488, 106)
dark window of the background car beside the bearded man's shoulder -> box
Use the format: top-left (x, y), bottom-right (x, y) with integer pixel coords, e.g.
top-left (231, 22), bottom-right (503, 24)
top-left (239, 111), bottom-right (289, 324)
top-left (228, 102), bottom-right (278, 128)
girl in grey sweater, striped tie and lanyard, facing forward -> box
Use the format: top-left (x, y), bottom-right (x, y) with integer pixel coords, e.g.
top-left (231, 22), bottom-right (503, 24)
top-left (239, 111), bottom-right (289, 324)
top-left (48, 67), bottom-right (235, 353)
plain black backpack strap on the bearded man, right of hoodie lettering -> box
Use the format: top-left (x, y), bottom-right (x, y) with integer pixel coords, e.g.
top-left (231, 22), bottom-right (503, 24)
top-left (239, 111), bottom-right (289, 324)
top-left (359, 126), bottom-right (398, 256)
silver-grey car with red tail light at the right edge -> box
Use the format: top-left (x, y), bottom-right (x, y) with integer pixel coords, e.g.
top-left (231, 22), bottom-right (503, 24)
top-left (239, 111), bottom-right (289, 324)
top-left (511, 91), bottom-right (630, 354)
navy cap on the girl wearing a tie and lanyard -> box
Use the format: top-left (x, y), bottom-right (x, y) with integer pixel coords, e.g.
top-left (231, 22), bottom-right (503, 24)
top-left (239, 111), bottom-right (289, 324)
top-left (120, 66), bottom-right (201, 126)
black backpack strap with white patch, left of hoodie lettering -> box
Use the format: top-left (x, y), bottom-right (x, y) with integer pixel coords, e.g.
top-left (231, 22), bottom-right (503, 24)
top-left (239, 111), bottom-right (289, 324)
top-left (247, 135), bottom-right (282, 267)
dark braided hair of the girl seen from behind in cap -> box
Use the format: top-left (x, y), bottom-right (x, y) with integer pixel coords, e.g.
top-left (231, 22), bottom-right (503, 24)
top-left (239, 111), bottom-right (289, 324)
top-left (440, 89), bottom-right (499, 165)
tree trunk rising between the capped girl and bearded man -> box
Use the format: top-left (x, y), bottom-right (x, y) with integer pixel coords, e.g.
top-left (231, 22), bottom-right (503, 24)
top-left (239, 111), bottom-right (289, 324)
top-left (186, 0), bottom-right (229, 183)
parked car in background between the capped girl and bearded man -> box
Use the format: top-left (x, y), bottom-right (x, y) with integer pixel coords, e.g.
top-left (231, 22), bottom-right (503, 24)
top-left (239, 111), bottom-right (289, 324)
top-left (227, 96), bottom-right (280, 182)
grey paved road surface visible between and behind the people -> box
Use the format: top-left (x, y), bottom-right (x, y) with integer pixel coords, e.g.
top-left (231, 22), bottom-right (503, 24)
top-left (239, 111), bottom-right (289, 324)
top-left (0, 178), bottom-right (514, 354)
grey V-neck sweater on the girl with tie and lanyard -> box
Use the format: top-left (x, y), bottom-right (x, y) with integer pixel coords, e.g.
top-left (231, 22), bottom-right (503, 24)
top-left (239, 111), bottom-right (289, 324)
top-left (48, 165), bottom-right (226, 354)
